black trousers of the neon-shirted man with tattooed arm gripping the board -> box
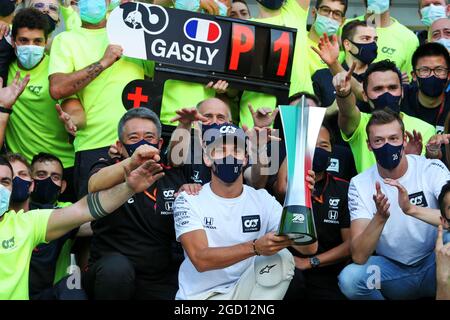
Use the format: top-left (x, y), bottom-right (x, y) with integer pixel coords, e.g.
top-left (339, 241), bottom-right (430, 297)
top-left (73, 147), bottom-right (109, 200)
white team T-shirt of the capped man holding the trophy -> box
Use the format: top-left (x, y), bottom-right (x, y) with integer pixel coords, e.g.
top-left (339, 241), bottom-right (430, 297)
top-left (174, 184), bottom-right (282, 299)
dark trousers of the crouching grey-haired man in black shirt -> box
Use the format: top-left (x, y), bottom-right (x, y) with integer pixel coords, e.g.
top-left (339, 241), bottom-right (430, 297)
top-left (82, 253), bottom-right (178, 300)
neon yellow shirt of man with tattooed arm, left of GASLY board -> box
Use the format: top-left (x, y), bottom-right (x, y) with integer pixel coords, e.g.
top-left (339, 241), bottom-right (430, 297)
top-left (49, 28), bottom-right (154, 152)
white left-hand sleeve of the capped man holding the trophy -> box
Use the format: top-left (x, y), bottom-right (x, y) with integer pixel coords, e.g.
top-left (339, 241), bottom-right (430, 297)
top-left (173, 192), bottom-right (203, 241)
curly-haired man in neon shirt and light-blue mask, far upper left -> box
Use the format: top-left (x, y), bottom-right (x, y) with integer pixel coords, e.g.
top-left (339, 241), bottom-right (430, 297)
top-left (2, 8), bottom-right (75, 201)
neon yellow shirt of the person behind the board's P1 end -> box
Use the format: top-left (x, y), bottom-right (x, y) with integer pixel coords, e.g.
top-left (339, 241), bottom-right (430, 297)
top-left (240, 0), bottom-right (313, 128)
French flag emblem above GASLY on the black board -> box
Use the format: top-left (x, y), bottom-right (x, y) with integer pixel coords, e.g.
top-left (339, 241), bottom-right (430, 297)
top-left (184, 18), bottom-right (222, 43)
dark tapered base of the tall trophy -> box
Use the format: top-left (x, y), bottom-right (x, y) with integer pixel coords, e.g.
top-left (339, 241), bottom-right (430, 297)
top-left (278, 206), bottom-right (317, 245)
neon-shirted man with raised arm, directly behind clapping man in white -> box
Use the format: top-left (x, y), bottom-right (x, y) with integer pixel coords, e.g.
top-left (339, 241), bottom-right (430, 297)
top-left (333, 60), bottom-right (436, 173)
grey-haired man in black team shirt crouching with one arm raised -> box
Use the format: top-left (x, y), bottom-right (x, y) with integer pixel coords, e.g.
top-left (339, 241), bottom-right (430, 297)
top-left (82, 108), bottom-right (185, 300)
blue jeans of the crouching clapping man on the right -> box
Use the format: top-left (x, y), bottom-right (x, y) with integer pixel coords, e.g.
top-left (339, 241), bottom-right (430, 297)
top-left (338, 252), bottom-right (436, 300)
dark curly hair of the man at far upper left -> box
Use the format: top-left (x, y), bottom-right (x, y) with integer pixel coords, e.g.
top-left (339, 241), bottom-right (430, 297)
top-left (11, 8), bottom-right (50, 39)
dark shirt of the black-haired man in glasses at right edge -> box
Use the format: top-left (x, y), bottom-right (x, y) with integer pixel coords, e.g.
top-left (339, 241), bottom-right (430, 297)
top-left (401, 83), bottom-right (450, 134)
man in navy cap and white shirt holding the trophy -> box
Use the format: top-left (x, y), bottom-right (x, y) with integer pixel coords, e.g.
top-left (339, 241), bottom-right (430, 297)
top-left (174, 123), bottom-right (317, 300)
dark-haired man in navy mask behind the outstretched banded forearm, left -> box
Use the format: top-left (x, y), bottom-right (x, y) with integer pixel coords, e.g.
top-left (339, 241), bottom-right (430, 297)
top-left (26, 153), bottom-right (92, 300)
